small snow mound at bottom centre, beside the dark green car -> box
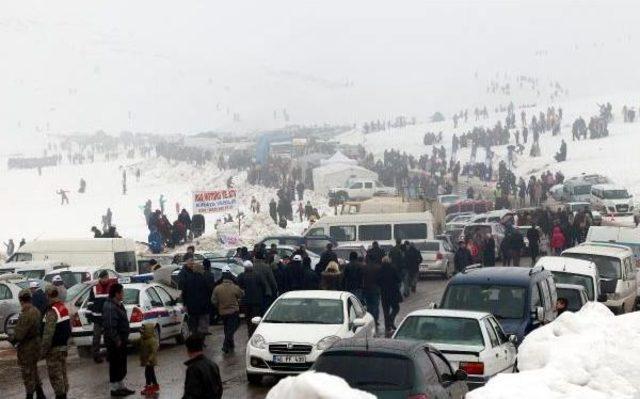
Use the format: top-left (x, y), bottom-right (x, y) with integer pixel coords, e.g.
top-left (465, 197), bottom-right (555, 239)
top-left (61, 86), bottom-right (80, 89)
top-left (267, 372), bottom-right (375, 399)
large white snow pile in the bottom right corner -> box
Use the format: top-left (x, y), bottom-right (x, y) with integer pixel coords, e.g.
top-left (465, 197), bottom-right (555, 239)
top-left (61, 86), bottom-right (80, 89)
top-left (467, 303), bottom-right (640, 399)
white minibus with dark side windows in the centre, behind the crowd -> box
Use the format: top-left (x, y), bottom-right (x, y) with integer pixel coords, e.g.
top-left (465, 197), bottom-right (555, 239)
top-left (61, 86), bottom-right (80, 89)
top-left (305, 212), bottom-right (433, 247)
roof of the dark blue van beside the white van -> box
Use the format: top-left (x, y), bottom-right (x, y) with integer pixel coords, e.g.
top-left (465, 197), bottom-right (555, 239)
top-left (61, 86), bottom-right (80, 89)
top-left (449, 266), bottom-right (544, 286)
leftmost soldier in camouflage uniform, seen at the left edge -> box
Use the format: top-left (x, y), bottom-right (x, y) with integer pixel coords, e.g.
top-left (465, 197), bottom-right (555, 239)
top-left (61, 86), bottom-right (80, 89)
top-left (11, 289), bottom-right (44, 398)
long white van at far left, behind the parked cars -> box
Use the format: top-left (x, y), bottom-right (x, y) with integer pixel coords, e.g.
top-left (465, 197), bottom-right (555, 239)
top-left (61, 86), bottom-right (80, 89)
top-left (5, 238), bottom-right (137, 273)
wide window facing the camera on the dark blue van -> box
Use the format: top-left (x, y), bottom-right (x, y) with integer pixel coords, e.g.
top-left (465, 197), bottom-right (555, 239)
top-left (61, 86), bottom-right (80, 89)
top-left (442, 284), bottom-right (526, 319)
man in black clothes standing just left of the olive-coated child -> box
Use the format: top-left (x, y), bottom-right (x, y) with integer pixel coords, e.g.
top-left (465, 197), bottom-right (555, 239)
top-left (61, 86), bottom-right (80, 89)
top-left (102, 283), bottom-right (134, 396)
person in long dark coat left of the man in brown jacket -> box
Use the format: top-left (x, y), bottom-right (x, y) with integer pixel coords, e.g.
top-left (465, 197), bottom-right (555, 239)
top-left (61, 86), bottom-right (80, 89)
top-left (178, 252), bottom-right (211, 334)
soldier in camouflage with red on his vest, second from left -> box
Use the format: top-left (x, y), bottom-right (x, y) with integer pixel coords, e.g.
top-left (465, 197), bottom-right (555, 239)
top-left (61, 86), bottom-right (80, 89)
top-left (42, 298), bottom-right (71, 399)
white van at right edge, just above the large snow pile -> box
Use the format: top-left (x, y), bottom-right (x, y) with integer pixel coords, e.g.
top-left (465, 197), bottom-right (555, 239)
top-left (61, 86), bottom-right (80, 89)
top-left (562, 242), bottom-right (638, 314)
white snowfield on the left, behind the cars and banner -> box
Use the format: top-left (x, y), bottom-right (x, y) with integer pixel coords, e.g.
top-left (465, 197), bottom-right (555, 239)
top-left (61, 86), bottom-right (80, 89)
top-left (0, 159), bottom-right (327, 253)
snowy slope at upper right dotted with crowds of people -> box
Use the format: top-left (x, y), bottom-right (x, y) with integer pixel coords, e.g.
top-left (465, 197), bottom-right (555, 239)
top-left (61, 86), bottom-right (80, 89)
top-left (338, 94), bottom-right (640, 197)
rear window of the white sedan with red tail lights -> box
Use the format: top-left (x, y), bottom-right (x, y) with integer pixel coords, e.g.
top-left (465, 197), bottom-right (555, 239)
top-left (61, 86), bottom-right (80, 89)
top-left (395, 316), bottom-right (484, 346)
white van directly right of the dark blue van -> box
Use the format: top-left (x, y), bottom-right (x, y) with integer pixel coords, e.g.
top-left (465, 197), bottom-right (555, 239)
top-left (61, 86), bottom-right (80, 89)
top-left (534, 256), bottom-right (606, 302)
